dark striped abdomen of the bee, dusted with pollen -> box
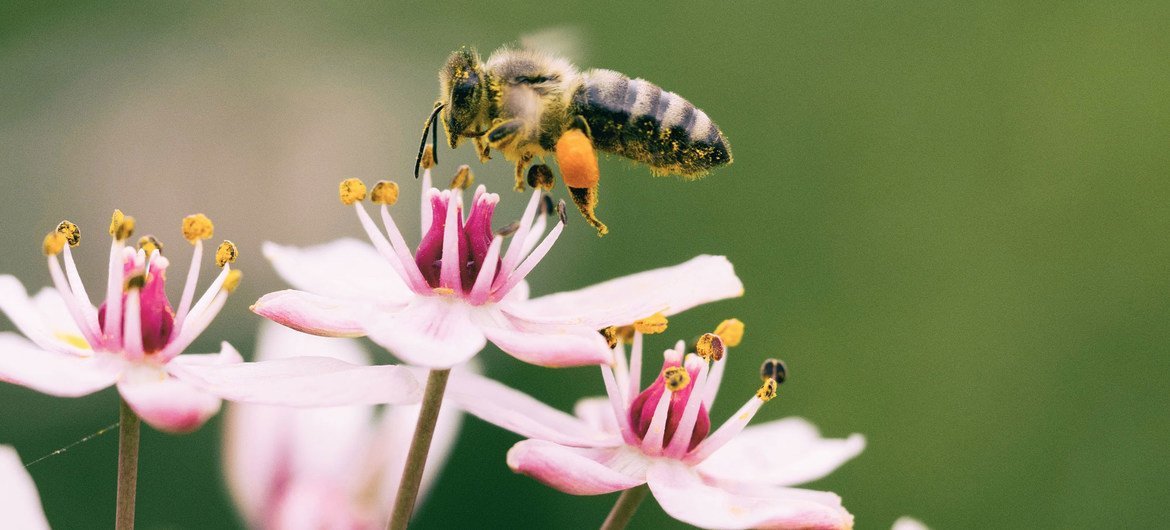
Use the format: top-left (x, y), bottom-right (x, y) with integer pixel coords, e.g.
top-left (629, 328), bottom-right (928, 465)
top-left (571, 70), bottom-right (731, 177)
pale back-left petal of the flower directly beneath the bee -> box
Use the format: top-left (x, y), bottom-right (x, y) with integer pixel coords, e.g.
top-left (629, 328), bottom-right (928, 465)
top-left (263, 238), bottom-right (412, 303)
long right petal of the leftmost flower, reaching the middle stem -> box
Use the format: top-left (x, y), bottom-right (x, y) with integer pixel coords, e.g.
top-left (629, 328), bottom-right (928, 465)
top-left (167, 356), bottom-right (421, 407)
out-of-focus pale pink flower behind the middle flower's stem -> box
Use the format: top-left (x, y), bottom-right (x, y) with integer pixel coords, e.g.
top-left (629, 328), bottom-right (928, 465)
top-left (223, 323), bottom-right (462, 530)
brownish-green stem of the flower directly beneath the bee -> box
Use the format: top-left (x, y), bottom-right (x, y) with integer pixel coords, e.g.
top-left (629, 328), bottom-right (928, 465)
top-left (388, 370), bottom-right (450, 530)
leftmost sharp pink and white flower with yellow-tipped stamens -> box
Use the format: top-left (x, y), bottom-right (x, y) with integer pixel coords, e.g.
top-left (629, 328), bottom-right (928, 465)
top-left (0, 211), bottom-right (420, 433)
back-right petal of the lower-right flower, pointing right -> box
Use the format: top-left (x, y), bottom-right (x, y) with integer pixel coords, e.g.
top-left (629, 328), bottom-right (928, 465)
top-left (698, 418), bottom-right (866, 486)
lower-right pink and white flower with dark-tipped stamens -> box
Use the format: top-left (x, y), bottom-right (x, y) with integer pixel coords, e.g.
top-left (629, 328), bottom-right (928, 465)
top-left (448, 321), bottom-right (865, 529)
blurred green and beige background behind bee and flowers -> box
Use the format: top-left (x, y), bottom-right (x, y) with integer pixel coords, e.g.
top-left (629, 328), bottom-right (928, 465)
top-left (0, 1), bottom-right (1170, 529)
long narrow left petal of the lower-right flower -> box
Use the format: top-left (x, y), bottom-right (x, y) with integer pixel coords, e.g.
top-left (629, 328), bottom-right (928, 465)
top-left (447, 371), bottom-right (621, 447)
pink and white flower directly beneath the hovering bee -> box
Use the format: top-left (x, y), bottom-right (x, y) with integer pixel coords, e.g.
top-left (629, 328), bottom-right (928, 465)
top-left (253, 170), bottom-right (743, 369)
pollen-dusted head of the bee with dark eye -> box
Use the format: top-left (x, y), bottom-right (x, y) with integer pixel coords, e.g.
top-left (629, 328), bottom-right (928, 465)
top-left (439, 47), bottom-right (491, 147)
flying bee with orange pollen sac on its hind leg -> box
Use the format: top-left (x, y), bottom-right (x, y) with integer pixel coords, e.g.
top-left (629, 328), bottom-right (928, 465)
top-left (415, 48), bottom-right (731, 234)
